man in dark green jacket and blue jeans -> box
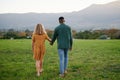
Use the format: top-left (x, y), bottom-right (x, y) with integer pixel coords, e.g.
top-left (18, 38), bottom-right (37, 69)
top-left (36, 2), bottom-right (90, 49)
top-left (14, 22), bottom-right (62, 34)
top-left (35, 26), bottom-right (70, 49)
top-left (51, 17), bottom-right (73, 77)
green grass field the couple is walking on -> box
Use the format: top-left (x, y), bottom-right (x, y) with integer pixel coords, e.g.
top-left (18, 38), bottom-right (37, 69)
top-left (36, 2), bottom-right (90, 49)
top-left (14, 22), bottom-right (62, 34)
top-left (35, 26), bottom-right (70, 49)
top-left (0, 39), bottom-right (120, 80)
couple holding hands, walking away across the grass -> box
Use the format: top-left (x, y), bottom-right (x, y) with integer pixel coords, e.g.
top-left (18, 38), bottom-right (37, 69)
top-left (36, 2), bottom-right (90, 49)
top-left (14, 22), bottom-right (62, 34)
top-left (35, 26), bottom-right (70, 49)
top-left (32, 17), bottom-right (73, 77)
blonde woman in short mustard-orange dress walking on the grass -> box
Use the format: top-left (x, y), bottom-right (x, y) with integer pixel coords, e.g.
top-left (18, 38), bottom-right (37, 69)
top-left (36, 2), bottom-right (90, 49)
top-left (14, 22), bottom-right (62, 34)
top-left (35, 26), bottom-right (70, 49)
top-left (32, 24), bottom-right (51, 76)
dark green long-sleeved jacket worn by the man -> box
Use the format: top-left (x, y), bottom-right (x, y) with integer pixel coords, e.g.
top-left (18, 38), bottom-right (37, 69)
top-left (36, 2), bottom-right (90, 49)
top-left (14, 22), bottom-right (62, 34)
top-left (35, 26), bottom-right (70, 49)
top-left (51, 23), bottom-right (73, 49)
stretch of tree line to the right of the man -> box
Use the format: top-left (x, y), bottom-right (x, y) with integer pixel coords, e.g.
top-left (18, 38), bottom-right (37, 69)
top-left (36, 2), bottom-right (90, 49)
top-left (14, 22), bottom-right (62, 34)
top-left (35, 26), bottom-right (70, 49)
top-left (75, 29), bottom-right (120, 39)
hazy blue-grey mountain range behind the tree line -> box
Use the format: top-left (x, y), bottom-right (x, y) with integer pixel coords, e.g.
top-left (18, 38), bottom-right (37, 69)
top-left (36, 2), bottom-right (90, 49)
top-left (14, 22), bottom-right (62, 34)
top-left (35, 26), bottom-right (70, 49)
top-left (0, 1), bottom-right (120, 30)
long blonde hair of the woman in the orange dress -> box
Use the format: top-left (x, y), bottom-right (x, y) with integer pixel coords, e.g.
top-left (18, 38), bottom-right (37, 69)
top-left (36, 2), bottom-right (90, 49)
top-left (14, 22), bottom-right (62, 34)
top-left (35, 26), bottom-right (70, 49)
top-left (33, 24), bottom-right (46, 35)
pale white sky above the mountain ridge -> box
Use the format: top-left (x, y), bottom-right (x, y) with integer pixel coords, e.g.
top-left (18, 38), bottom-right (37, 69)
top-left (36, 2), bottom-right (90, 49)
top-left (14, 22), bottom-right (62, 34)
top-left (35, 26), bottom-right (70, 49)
top-left (0, 0), bottom-right (116, 13)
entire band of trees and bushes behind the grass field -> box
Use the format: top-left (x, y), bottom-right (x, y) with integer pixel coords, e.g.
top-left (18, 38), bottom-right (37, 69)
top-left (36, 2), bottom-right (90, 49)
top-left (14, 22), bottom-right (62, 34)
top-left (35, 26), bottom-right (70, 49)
top-left (0, 29), bottom-right (120, 39)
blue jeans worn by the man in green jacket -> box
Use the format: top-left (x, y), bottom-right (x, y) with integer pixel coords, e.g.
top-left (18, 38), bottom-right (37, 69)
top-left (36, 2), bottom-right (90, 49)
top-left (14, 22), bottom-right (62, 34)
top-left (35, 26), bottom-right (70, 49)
top-left (58, 49), bottom-right (68, 74)
